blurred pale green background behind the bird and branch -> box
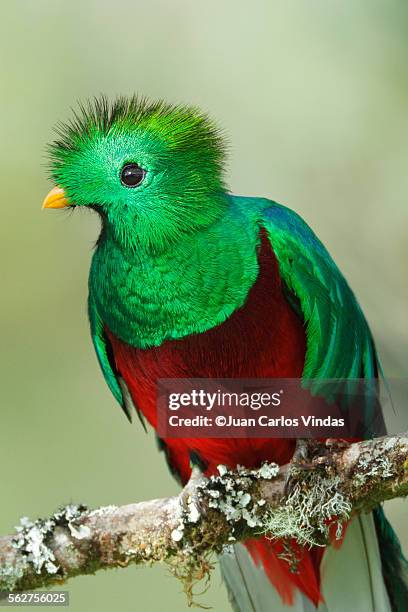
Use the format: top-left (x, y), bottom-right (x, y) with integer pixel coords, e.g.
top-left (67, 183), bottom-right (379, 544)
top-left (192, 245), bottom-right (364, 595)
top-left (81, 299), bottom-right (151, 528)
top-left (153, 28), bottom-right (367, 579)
top-left (0, 0), bottom-right (408, 612)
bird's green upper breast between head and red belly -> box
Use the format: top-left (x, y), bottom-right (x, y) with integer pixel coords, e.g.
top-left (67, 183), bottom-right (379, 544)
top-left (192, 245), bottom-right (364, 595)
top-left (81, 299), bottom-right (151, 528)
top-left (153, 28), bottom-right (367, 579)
top-left (89, 198), bottom-right (259, 348)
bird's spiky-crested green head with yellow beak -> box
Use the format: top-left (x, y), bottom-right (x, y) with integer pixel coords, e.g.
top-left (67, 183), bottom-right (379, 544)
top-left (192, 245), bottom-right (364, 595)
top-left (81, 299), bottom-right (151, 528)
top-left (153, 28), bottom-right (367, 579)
top-left (43, 97), bottom-right (227, 250)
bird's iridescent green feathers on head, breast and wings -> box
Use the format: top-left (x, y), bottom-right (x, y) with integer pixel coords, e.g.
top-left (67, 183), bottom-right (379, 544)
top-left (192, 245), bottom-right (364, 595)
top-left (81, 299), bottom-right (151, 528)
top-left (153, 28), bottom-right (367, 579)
top-left (46, 98), bottom-right (406, 611)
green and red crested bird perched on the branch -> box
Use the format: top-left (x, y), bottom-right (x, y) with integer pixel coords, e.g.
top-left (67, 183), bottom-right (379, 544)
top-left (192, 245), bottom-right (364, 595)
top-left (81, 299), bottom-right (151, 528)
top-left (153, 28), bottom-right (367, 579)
top-left (43, 95), bottom-right (408, 612)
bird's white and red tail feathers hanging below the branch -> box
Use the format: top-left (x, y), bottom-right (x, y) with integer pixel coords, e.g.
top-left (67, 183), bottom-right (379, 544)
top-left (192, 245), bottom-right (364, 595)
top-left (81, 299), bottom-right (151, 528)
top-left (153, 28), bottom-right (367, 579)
top-left (220, 511), bottom-right (398, 612)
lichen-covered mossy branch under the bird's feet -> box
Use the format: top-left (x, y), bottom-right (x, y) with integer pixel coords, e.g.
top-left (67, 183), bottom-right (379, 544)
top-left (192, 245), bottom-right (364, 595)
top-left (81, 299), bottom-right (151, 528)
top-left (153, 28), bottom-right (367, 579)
top-left (0, 434), bottom-right (408, 591)
